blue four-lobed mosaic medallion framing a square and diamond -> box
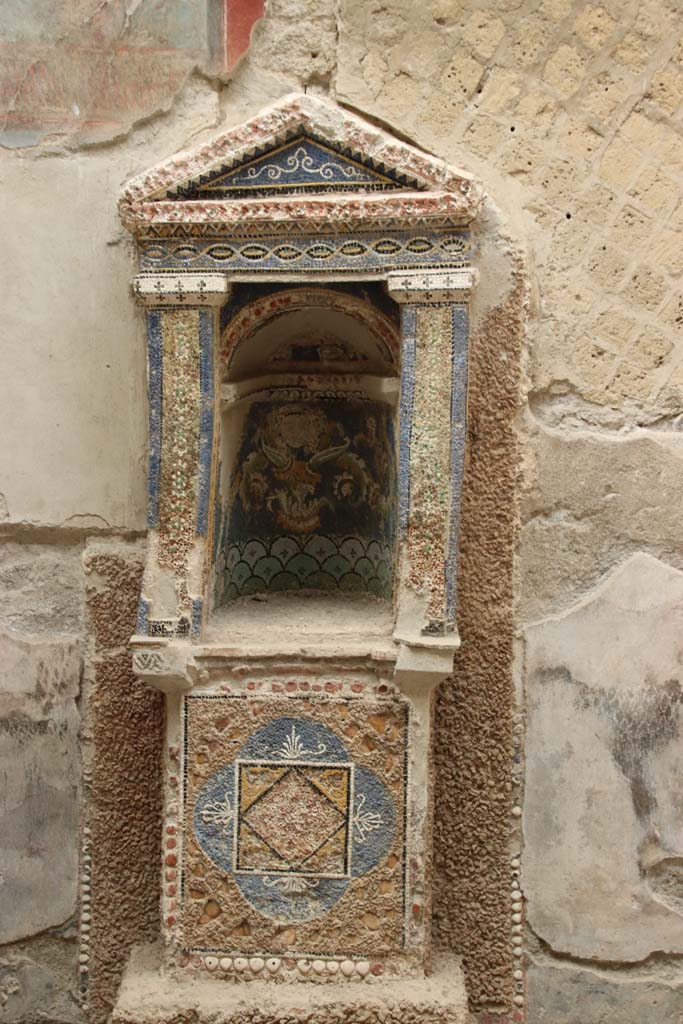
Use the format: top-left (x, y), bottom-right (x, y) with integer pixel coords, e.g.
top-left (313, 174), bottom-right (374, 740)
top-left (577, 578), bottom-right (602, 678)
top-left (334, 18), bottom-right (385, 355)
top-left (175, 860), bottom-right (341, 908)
top-left (193, 717), bottom-right (396, 923)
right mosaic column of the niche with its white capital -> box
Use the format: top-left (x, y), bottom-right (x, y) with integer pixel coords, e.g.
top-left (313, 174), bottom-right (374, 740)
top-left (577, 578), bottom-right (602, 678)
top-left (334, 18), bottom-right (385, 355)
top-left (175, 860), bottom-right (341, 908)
top-left (388, 269), bottom-right (473, 648)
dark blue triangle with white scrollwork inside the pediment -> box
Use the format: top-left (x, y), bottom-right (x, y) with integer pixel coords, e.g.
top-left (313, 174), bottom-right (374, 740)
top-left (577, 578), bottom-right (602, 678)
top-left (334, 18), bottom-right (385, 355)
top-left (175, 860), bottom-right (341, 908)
top-left (167, 132), bottom-right (424, 200)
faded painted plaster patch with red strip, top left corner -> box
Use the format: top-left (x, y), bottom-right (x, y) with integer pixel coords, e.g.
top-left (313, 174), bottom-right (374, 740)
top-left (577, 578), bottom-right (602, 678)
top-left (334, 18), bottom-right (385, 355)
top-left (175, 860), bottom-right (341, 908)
top-left (0, 0), bottom-right (231, 147)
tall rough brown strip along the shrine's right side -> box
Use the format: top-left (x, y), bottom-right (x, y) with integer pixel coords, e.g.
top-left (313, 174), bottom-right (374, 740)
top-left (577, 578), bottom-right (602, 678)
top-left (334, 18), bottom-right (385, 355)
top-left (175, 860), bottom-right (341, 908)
top-left (434, 268), bottom-right (525, 1009)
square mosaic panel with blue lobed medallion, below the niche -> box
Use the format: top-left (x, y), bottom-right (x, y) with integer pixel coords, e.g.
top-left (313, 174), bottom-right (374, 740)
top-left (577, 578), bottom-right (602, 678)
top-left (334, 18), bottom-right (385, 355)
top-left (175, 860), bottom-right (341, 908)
top-left (182, 694), bottom-right (408, 956)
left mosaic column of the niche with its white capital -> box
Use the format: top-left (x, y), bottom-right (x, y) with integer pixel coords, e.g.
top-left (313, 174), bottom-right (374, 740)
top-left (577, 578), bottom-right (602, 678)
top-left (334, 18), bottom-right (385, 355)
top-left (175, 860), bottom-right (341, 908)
top-left (134, 273), bottom-right (229, 655)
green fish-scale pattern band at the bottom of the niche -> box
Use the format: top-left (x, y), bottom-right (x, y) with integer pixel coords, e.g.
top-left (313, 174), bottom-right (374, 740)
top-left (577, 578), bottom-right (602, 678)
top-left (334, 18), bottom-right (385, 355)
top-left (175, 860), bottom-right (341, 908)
top-left (223, 535), bottom-right (392, 601)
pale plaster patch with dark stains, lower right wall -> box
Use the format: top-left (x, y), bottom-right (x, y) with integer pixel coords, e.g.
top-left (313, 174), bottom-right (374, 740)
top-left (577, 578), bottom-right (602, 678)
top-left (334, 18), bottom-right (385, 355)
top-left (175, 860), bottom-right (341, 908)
top-left (523, 554), bottom-right (683, 962)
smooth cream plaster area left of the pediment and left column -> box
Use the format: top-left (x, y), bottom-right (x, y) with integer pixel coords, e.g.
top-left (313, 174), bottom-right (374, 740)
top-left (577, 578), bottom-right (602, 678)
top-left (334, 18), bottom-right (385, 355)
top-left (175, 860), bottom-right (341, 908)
top-left (0, 76), bottom-right (217, 530)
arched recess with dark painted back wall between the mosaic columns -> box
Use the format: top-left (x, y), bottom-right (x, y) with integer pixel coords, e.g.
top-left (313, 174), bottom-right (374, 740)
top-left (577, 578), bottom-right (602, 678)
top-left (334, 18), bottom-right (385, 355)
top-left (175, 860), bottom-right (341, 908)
top-left (214, 286), bottom-right (400, 615)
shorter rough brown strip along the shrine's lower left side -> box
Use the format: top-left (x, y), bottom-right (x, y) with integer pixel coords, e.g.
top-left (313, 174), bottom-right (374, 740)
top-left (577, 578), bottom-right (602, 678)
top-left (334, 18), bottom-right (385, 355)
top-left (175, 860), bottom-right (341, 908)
top-left (81, 542), bottom-right (164, 1020)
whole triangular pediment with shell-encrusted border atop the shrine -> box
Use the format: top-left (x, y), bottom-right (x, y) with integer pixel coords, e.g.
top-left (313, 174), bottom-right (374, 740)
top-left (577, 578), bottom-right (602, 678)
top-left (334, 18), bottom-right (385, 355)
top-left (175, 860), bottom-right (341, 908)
top-left (119, 95), bottom-right (481, 238)
